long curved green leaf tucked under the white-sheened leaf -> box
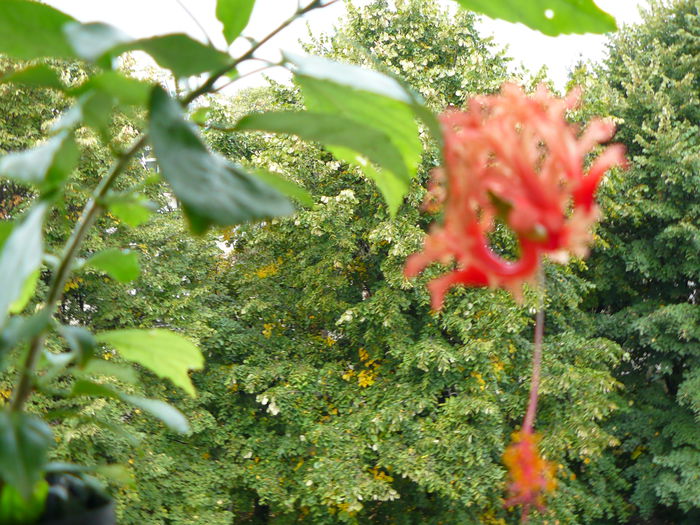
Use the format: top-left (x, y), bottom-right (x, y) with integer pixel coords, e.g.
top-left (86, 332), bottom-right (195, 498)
top-left (236, 111), bottom-right (411, 213)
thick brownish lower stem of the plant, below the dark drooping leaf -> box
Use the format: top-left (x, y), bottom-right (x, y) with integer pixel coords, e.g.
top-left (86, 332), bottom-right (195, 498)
top-left (10, 135), bottom-right (146, 412)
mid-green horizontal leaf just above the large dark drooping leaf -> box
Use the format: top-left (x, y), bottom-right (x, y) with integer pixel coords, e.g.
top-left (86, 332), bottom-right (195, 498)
top-left (115, 34), bottom-right (233, 78)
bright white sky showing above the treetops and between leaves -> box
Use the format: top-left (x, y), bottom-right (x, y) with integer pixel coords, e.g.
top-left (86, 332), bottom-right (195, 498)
top-left (45, 0), bottom-right (647, 87)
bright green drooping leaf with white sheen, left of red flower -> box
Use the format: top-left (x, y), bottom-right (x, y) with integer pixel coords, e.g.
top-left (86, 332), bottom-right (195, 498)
top-left (285, 54), bottom-right (424, 215)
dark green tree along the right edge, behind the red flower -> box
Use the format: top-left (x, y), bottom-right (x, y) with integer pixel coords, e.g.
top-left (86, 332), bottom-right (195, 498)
top-left (587, 0), bottom-right (700, 523)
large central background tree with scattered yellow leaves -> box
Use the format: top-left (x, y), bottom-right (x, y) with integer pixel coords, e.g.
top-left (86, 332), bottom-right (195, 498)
top-left (149, 2), bottom-right (621, 524)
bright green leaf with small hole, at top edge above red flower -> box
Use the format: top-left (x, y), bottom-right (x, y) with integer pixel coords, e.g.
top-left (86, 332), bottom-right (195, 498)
top-left (456, 0), bottom-right (617, 36)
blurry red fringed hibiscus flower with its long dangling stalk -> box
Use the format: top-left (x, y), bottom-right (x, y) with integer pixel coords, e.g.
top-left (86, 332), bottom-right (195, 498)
top-left (405, 84), bottom-right (625, 520)
